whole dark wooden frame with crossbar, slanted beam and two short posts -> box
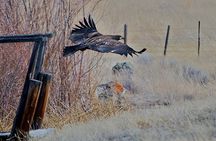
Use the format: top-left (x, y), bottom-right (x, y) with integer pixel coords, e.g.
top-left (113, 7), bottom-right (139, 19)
top-left (0, 33), bottom-right (52, 141)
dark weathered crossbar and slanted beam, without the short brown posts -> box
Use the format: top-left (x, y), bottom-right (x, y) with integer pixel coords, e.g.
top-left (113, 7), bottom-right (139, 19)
top-left (0, 33), bottom-right (53, 139)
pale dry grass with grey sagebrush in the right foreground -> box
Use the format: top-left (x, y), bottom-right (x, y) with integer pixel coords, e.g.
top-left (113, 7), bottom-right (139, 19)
top-left (32, 53), bottom-right (216, 141)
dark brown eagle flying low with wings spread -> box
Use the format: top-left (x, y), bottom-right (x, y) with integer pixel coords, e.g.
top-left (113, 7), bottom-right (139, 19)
top-left (63, 15), bottom-right (146, 57)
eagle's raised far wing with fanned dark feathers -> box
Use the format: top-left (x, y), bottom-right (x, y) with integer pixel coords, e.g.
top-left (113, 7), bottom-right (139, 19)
top-left (69, 15), bottom-right (101, 44)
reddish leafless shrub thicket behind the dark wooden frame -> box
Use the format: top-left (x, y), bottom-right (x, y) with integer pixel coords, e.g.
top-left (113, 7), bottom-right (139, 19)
top-left (0, 0), bottom-right (125, 131)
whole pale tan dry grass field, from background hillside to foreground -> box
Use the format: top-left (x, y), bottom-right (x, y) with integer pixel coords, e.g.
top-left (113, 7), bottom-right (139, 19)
top-left (37, 0), bottom-right (216, 141)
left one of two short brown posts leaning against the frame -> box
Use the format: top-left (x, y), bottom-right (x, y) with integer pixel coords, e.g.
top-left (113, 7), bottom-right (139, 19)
top-left (16, 79), bottom-right (42, 139)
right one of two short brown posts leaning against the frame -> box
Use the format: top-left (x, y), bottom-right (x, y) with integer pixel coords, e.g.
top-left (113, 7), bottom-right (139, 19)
top-left (32, 73), bottom-right (51, 129)
